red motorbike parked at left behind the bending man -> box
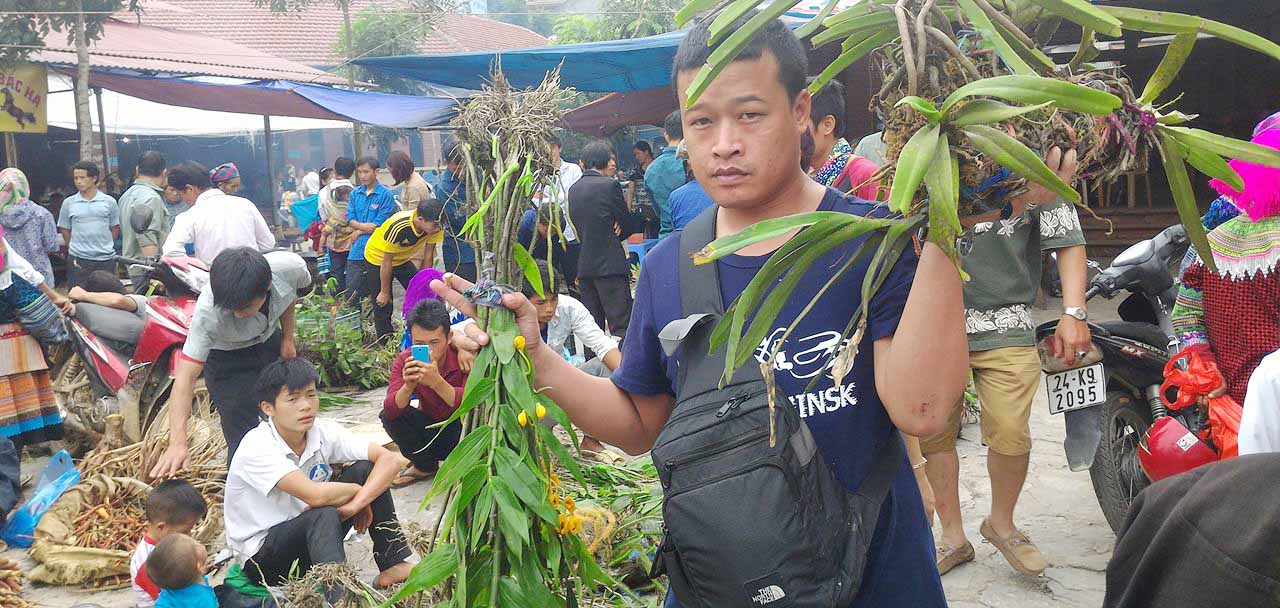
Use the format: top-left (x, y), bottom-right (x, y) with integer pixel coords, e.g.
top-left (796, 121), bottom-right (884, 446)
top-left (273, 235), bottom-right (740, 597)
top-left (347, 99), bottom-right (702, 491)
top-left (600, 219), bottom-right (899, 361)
top-left (54, 256), bottom-right (210, 442)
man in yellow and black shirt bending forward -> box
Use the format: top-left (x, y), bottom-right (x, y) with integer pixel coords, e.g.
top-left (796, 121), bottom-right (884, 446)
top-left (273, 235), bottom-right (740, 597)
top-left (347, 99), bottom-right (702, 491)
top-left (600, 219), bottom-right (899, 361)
top-left (362, 198), bottom-right (444, 337)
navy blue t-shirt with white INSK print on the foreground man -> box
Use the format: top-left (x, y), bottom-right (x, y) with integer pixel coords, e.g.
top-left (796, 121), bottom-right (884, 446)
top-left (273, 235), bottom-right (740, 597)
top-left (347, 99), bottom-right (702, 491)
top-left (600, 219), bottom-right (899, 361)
top-left (612, 189), bottom-right (946, 608)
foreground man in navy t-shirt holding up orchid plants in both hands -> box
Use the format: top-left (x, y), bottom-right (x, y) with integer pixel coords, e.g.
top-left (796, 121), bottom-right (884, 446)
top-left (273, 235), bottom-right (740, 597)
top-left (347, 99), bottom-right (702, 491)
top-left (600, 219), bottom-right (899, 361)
top-left (433, 20), bottom-right (983, 608)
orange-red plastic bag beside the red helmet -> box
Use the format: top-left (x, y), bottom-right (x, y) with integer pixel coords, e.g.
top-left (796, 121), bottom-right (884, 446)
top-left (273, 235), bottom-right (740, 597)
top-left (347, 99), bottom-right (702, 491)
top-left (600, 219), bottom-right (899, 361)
top-left (1160, 347), bottom-right (1244, 460)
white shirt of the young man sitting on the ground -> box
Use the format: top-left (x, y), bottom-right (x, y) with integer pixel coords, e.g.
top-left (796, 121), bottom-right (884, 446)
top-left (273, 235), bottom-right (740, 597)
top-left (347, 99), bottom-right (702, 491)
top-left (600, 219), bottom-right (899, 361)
top-left (224, 420), bottom-right (370, 559)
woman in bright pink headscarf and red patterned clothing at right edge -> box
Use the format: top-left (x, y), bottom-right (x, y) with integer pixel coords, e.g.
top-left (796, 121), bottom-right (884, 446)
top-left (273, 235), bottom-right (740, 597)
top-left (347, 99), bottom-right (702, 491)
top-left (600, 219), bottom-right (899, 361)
top-left (1172, 113), bottom-right (1280, 403)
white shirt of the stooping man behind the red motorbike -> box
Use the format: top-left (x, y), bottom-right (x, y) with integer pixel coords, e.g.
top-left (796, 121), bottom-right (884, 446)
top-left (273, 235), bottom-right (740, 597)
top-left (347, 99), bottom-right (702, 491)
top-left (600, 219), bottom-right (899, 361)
top-left (164, 188), bottom-right (275, 264)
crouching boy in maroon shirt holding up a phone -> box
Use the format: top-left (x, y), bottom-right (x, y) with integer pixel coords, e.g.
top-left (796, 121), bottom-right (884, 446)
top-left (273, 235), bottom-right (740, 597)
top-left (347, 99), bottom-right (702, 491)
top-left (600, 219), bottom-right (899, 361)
top-left (381, 300), bottom-right (467, 488)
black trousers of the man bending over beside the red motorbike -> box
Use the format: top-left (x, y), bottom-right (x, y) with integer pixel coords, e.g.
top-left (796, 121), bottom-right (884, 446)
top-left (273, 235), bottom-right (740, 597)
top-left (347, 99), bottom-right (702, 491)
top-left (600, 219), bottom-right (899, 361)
top-left (205, 332), bottom-right (280, 466)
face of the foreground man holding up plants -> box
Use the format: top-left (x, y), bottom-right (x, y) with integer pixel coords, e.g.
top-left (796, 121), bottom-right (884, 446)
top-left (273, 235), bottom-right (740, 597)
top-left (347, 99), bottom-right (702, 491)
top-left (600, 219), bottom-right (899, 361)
top-left (676, 52), bottom-right (810, 209)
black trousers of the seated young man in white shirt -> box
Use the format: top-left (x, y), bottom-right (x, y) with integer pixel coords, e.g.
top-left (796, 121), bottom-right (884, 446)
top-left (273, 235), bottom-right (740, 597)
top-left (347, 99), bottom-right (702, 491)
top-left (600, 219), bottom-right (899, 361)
top-left (244, 461), bottom-right (410, 585)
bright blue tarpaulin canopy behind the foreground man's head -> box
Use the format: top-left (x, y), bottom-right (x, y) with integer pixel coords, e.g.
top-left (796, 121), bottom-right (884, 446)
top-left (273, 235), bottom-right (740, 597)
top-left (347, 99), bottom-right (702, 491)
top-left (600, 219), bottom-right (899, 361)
top-left (356, 31), bottom-right (686, 92)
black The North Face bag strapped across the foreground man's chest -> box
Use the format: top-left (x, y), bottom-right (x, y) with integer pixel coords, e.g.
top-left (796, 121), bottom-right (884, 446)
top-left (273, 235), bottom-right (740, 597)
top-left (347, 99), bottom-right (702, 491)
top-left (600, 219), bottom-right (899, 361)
top-left (652, 206), bottom-right (904, 608)
